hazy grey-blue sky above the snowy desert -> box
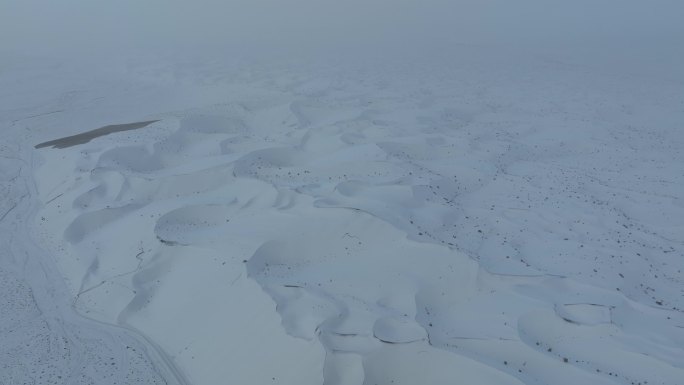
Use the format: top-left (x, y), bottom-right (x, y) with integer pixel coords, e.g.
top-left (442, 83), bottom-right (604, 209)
top-left (0, 0), bottom-right (684, 59)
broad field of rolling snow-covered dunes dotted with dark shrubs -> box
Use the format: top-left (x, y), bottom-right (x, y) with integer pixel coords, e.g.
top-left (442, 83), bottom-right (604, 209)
top-left (28, 54), bottom-right (684, 385)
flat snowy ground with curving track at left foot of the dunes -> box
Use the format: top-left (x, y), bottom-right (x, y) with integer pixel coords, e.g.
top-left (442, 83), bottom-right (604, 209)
top-left (0, 133), bottom-right (184, 385)
